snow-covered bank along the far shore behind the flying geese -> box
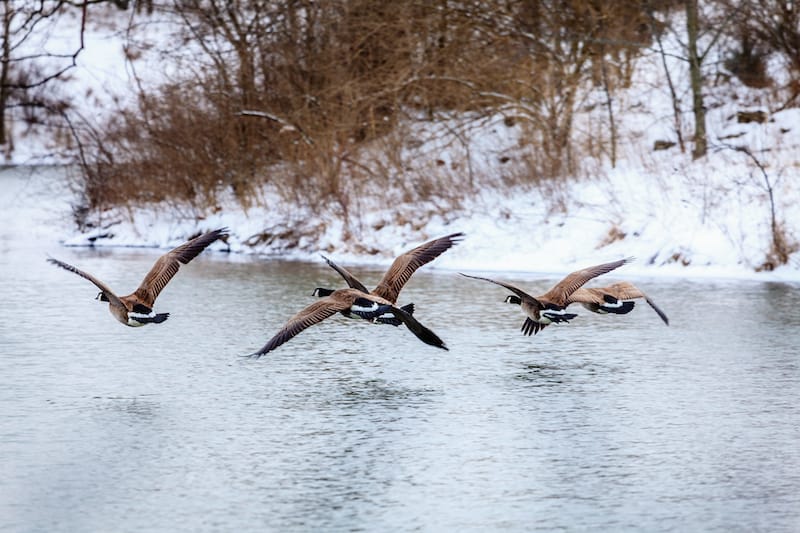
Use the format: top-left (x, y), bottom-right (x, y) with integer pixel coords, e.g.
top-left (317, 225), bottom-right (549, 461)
top-left (57, 101), bottom-right (800, 280)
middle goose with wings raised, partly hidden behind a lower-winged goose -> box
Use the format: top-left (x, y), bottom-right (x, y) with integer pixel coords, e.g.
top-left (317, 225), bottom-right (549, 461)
top-left (312, 232), bottom-right (464, 326)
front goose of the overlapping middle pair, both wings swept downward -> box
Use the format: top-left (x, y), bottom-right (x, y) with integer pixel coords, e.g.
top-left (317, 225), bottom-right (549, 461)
top-left (250, 289), bottom-right (447, 359)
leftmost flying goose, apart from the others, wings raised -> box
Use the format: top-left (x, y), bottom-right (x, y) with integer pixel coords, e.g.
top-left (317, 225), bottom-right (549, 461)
top-left (47, 228), bottom-right (228, 327)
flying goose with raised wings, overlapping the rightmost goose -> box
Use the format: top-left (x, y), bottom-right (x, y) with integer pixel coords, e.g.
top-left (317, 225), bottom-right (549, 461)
top-left (461, 258), bottom-right (632, 335)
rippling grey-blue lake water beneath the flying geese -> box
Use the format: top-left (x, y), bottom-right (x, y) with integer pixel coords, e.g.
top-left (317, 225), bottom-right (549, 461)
top-left (0, 165), bottom-right (800, 532)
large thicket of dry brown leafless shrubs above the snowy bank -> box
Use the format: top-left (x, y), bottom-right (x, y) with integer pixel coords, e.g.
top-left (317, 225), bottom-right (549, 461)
top-left (75, 0), bottom-right (660, 224)
